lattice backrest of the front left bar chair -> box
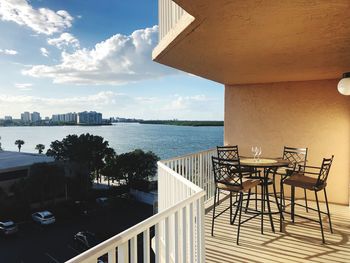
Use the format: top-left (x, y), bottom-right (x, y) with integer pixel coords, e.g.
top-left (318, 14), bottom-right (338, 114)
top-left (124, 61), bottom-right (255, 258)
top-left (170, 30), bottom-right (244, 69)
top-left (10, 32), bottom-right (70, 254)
top-left (212, 157), bottom-right (243, 187)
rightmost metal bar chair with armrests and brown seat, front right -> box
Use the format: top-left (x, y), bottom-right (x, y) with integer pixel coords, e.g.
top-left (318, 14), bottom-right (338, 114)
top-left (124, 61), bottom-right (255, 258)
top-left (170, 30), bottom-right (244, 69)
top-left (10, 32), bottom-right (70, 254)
top-left (283, 155), bottom-right (334, 243)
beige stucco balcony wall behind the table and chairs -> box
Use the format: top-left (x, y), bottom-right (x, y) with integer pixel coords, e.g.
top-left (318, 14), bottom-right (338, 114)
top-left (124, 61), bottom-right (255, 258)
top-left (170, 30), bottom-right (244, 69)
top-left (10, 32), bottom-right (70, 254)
top-left (225, 80), bottom-right (350, 204)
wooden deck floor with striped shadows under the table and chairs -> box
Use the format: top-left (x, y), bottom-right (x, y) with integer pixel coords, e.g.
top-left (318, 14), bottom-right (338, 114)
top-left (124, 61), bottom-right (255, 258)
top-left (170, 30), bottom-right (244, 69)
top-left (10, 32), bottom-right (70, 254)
top-left (205, 195), bottom-right (350, 263)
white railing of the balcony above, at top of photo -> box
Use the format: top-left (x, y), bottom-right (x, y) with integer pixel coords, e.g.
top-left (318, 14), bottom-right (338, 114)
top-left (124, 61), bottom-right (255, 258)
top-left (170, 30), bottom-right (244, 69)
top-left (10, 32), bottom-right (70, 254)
top-left (158, 0), bottom-right (186, 40)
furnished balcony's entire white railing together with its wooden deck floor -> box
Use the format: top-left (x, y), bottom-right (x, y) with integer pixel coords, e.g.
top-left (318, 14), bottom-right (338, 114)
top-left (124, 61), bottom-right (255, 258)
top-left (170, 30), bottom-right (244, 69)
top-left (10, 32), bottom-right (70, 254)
top-left (68, 150), bottom-right (350, 263)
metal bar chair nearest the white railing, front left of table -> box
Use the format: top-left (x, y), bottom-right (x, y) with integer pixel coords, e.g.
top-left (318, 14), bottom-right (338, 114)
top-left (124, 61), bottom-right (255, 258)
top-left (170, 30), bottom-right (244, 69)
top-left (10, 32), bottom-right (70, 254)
top-left (211, 157), bottom-right (260, 245)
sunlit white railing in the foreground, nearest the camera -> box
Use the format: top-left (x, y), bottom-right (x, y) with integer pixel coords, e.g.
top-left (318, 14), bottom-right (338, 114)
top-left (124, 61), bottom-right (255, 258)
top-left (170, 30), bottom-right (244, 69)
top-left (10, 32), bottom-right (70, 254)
top-left (67, 162), bottom-right (205, 263)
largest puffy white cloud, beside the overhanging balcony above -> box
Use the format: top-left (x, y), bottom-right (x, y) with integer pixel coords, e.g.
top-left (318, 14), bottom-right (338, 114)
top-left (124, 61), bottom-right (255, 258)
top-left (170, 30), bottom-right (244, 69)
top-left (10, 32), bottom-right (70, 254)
top-left (22, 26), bottom-right (178, 85)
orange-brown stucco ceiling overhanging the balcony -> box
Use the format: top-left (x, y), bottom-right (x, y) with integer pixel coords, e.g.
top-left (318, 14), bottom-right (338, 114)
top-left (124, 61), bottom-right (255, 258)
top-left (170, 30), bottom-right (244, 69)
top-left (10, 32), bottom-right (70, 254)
top-left (154, 0), bottom-right (350, 84)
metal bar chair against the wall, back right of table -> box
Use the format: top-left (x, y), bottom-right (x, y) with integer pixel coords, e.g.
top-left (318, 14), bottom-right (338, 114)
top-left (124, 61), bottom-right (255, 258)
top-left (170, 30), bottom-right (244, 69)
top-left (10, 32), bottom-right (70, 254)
top-left (273, 146), bottom-right (308, 212)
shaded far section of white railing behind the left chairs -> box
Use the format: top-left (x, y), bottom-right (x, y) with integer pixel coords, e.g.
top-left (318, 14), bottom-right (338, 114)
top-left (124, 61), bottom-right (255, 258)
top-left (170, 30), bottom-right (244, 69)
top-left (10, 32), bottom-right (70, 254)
top-left (162, 149), bottom-right (216, 201)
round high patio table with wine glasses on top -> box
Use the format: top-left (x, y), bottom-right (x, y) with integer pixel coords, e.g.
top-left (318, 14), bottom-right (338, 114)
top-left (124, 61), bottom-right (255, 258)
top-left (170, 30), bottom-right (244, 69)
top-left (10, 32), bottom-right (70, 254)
top-left (240, 157), bottom-right (291, 234)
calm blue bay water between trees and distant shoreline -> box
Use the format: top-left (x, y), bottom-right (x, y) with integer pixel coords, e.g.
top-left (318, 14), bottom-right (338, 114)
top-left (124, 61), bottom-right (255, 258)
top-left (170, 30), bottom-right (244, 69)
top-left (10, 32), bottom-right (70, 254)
top-left (0, 123), bottom-right (224, 159)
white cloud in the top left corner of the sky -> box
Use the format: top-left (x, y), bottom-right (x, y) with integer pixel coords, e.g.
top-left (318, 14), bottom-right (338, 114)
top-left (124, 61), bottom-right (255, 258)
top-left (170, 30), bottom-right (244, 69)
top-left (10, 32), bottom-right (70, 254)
top-left (0, 0), bottom-right (73, 35)
